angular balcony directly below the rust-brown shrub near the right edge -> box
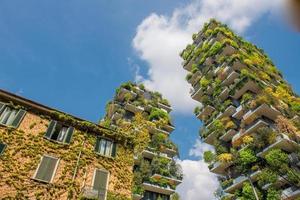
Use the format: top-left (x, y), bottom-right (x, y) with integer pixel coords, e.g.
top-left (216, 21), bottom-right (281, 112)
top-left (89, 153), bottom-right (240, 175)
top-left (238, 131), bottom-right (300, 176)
top-left (257, 134), bottom-right (299, 157)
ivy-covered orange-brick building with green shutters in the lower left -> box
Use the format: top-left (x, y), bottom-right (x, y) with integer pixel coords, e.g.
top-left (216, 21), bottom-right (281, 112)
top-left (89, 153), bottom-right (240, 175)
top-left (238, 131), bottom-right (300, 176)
top-left (0, 90), bottom-right (134, 200)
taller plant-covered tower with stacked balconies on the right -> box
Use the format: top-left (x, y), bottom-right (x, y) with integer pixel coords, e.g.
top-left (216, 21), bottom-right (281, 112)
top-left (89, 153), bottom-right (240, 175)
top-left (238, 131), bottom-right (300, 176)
top-left (181, 20), bottom-right (300, 200)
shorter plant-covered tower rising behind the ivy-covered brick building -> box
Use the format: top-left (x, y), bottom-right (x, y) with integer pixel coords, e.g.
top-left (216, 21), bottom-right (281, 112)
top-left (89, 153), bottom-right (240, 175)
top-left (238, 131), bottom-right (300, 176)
top-left (105, 82), bottom-right (182, 200)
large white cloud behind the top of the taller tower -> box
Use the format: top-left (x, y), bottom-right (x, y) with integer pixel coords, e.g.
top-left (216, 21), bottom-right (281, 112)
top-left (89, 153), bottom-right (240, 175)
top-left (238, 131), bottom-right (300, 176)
top-left (133, 0), bottom-right (282, 113)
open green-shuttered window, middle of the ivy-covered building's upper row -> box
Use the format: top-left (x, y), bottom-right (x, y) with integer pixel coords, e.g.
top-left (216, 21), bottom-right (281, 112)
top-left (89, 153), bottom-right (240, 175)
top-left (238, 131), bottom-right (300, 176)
top-left (45, 120), bottom-right (74, 144)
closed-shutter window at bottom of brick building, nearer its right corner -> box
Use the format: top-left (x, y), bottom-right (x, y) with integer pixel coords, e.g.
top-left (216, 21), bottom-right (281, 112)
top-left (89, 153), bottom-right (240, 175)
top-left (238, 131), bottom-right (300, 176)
top-left (93, 169), bottom-right (109, 200)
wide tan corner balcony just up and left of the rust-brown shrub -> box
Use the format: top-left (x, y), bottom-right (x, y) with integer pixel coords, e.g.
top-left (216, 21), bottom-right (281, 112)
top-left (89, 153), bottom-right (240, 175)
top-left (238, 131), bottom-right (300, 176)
top-left (243, 104), bottom-right (281, 125)
